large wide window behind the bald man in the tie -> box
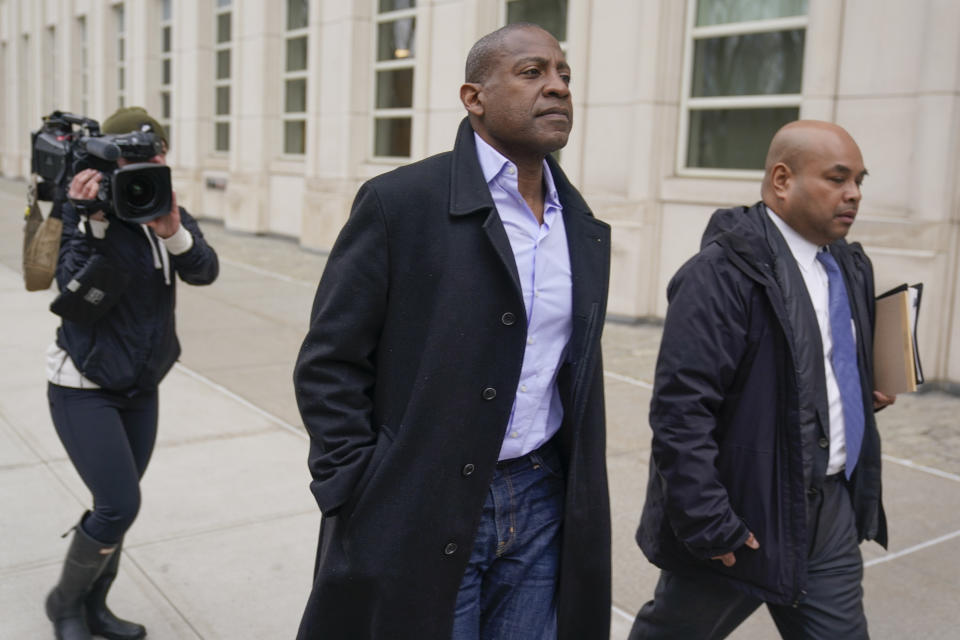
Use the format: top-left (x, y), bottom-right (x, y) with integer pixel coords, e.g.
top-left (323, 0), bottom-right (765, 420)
top-left (677, 0), bottom-right (807, 175)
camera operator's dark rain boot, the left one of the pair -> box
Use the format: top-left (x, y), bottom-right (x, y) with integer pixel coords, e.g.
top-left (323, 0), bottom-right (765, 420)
top-left (46, 518), bottom-right (115, 640)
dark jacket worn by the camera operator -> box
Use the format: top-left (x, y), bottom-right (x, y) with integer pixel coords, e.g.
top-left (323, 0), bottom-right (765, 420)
top-left (57, 203), bottom-right (219, 394)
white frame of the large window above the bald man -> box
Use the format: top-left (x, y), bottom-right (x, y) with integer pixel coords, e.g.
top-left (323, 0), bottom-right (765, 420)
top-left (675, 0), bottom-right (810, 180)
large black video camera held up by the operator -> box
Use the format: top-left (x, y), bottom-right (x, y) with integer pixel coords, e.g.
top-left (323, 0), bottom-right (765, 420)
top-left (30, 111), bottom-right (173, 223)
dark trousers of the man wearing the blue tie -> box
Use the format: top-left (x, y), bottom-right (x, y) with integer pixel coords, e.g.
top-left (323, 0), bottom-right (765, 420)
top-left (630, 474), bottom-right (869, 640)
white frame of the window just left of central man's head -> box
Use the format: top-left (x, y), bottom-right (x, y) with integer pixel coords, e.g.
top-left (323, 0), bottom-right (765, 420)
top-left (369, 0), bottom-right (422, 163)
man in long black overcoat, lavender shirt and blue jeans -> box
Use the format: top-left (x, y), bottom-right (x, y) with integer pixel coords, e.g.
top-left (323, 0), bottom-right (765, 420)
top-left (294, 24), bottom-right (610, 640)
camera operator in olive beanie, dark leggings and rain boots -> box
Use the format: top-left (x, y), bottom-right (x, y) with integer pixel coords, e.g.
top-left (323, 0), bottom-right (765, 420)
top-left (46, 107), bottom-right (218, 640)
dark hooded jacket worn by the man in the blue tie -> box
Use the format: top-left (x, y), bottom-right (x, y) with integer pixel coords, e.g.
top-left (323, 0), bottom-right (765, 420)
top-left (637, 202), bottom-right (887, 604)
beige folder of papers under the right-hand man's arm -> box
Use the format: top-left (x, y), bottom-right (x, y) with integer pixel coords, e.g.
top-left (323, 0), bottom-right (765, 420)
top-left (873, 284), bottom-right (923, 396)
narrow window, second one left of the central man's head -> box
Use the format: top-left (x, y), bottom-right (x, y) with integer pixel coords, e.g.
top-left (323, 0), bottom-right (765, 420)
top-left (283, 0), bottom-right (309, 155)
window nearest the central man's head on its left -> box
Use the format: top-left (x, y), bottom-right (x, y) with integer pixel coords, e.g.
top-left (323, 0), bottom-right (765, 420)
top-left (373, 0), bottom-right (417, 158)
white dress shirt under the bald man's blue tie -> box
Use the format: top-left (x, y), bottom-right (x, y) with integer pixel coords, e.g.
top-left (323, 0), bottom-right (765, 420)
top-left (766, 207), bottom-right (856, 475)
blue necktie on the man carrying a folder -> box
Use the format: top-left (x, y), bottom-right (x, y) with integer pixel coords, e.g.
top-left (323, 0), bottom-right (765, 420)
top-left (817, 251), bottom-right (863, 480)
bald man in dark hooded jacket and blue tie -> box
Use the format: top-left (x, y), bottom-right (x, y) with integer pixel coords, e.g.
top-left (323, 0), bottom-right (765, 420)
top-left (630, 120), bottom-right (894, 640)
